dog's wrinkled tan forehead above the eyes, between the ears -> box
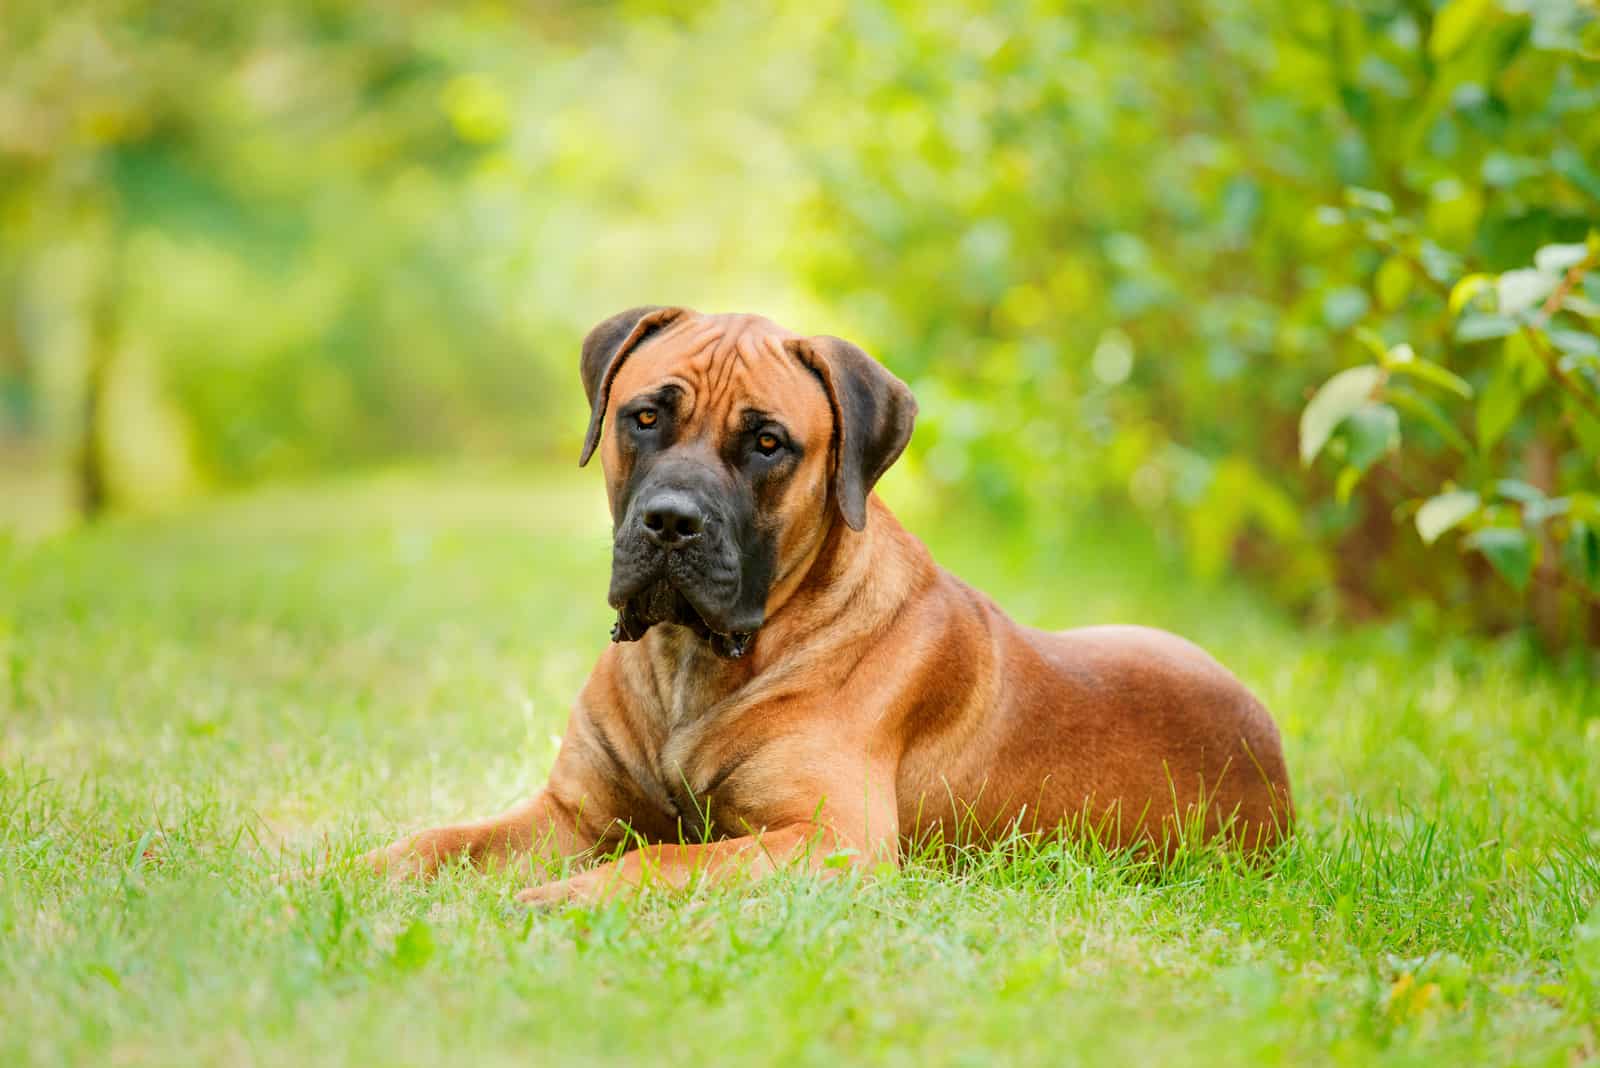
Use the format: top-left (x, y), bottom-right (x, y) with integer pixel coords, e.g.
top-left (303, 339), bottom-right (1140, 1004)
top-left (611, 315), bottom-right (832, 441)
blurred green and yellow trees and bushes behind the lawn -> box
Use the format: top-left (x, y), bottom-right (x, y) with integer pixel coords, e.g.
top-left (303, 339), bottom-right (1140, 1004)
top-left (0, 0), bottom-right (1600, 651)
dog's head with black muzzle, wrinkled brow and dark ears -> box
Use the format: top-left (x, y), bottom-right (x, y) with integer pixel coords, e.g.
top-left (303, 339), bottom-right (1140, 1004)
top-left (582, 309), bottom-right (917, 657)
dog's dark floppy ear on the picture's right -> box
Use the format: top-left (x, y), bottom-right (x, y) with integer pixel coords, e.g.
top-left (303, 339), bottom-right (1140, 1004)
top-left (784, 336), bottom-right (917, 531)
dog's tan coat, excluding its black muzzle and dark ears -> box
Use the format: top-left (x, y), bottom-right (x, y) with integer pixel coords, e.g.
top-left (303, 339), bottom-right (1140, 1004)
top-left (368, 315), bottom-right (1291, 903)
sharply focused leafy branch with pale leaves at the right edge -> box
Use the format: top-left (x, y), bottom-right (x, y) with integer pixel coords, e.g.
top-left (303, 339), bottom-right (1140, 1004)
top-left (1301, 222), bottom-right (1600, 620)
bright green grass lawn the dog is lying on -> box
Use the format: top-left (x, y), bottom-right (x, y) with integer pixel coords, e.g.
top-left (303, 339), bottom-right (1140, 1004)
top-left (0, 473), bottom-right (1600, 1065)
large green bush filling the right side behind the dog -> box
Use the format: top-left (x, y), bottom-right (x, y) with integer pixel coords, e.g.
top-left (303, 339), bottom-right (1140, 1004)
top-left (800, 0), bottom-right (1600, 640)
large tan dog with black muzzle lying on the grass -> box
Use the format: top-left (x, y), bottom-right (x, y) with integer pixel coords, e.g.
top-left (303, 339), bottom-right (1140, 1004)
top-left (365, 307), bottom-right (1291, 903)
